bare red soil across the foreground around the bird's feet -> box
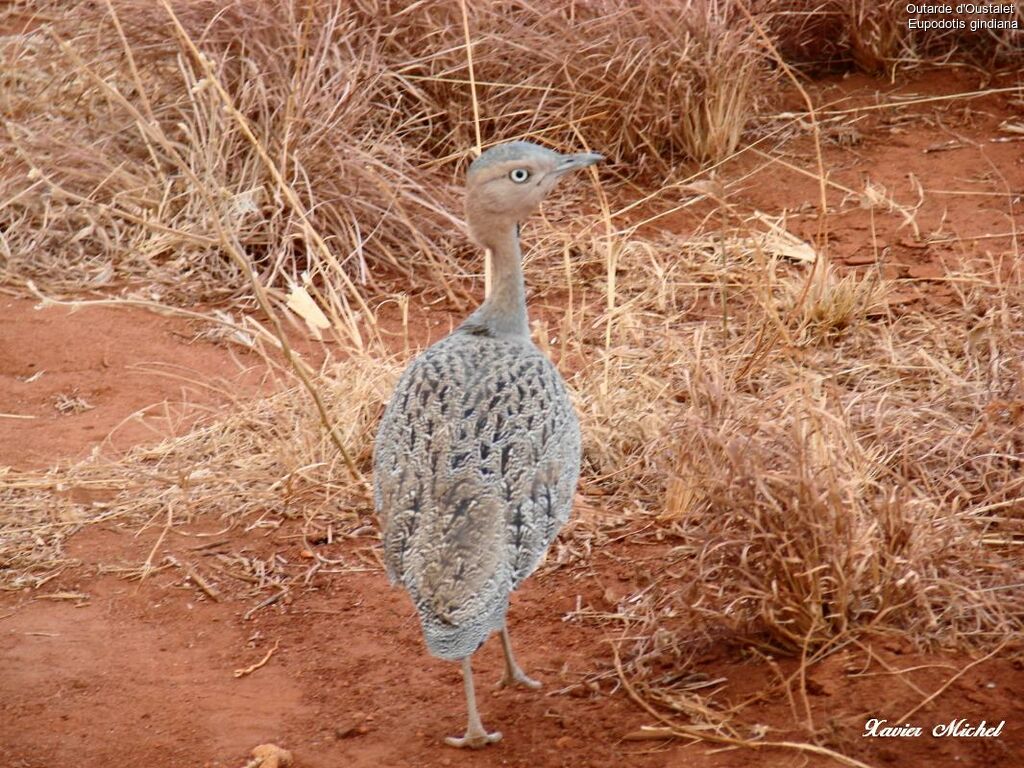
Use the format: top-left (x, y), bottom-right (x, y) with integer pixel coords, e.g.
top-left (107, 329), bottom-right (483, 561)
top-left (6, 518), bottom-right (1024, 768)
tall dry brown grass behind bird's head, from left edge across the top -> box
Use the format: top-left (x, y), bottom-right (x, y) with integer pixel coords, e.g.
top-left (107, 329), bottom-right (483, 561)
top-left (0, 0), bottom-right (768, 307)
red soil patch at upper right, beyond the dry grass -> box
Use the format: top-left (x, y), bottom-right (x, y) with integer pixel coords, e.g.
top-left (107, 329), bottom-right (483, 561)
top-left (655, 71), bottom-right (1024, 306)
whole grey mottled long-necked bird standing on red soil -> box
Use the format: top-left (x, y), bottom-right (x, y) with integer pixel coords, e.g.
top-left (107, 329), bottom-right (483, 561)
top-left (373, 140), bottom-right (604, 749)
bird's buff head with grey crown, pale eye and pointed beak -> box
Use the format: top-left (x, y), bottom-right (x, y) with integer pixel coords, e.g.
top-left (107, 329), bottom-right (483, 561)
top-left (466, 141), bottom-right (604, 247)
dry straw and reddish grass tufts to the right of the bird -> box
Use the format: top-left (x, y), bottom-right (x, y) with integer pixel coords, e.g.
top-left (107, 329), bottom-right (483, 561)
top-left (544, 241), bottom-right (1024, 742)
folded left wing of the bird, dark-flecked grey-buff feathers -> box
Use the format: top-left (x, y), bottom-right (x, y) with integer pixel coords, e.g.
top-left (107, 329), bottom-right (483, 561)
top-left (374, 352), bottom-right (511, 626)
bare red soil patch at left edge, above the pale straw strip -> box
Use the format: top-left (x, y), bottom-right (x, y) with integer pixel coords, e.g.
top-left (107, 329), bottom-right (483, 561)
top-left (0, 294), bottom-right (263, 469)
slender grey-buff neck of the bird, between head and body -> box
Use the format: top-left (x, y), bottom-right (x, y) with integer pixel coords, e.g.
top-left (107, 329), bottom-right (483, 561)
top-left (469, 224), bottom-right (529, 339)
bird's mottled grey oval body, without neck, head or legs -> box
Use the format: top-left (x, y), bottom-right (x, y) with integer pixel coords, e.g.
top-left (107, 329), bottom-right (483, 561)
top-left (374, 325), bottom-right (580, 659)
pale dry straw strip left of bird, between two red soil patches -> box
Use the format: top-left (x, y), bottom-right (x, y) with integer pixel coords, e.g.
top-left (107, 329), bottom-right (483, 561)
top-left (0, 356), bottom-right (400, 590)
